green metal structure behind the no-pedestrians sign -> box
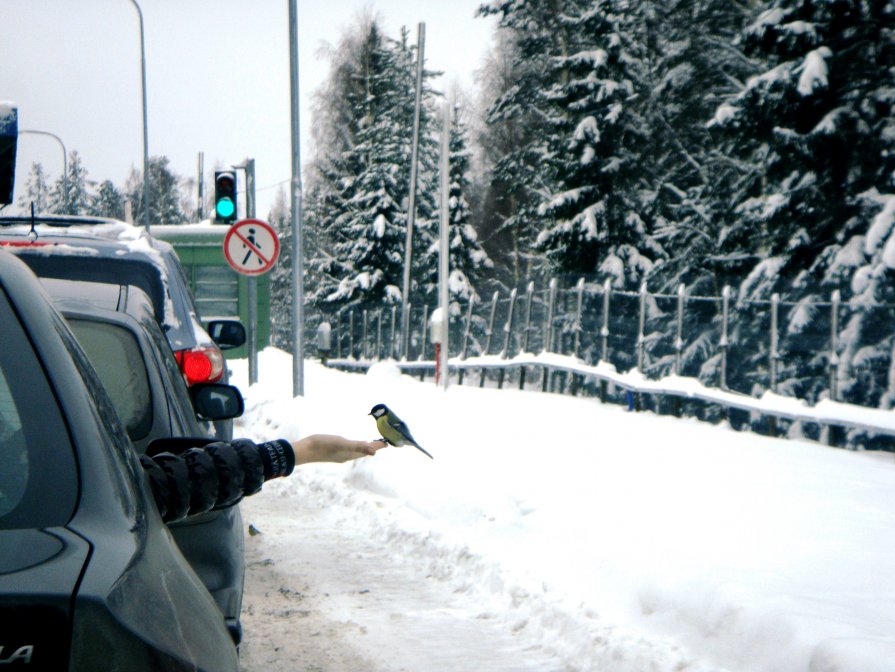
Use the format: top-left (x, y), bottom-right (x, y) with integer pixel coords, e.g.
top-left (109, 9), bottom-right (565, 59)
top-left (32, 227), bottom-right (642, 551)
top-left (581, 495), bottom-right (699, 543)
top-left (152, 222), bottom-right (270, 359)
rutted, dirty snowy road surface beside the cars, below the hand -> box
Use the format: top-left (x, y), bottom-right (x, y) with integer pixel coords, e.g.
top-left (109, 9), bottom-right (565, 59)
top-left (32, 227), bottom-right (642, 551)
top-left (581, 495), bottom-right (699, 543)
top-left (241, 476), bottom-right (568, 672)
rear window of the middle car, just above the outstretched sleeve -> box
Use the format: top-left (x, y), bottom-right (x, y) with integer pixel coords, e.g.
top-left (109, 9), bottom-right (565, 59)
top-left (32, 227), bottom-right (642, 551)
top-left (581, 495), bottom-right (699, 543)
top-left (67, 318), bottom-right (152, 441)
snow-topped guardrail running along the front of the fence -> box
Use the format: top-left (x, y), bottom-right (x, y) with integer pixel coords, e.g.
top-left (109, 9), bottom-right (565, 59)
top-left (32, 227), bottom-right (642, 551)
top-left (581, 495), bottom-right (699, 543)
top-left (325, 352), bottom-right (895, 444)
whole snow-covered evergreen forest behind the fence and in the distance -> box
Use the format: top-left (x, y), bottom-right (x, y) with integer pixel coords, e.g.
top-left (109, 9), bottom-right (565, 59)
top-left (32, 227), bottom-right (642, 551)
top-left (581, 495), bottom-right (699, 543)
top-left (14, 0), bottom-right (895, 440)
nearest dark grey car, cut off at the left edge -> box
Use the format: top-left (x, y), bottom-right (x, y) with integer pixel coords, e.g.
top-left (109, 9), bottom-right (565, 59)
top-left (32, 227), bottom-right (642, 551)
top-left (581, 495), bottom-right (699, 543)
top-left (0, 250), bottom-right (239, 672)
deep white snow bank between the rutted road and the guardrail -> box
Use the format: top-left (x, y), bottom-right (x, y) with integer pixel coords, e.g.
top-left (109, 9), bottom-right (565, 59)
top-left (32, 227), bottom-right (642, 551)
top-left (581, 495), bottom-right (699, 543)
top-left (235, 349), bottom-right (895, 672)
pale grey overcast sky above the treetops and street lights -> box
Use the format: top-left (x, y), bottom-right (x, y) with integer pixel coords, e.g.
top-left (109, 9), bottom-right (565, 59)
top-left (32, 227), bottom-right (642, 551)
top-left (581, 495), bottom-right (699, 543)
top-left (0, 0), bottom-right (494, 217)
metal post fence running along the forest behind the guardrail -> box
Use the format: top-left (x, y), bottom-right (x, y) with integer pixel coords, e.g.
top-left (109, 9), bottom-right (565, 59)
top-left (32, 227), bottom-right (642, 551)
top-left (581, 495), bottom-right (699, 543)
top-left (316, 279), bottom-right (895, 449)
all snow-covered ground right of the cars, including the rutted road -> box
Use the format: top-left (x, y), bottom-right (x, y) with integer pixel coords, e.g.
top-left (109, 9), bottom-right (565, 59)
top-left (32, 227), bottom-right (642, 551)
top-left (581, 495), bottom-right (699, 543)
top-left (233, 348), bottom-right (895, 672)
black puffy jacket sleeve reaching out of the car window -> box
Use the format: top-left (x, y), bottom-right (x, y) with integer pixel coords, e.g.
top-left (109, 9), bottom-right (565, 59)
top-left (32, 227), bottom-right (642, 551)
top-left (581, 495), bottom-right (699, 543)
top-left (140, 439), bottom-right (295, 522)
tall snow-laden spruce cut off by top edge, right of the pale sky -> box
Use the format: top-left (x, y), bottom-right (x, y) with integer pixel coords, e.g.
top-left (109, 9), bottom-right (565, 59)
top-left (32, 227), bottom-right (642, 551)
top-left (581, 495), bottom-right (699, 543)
top-left (486, 0), bottom-right (663, 367)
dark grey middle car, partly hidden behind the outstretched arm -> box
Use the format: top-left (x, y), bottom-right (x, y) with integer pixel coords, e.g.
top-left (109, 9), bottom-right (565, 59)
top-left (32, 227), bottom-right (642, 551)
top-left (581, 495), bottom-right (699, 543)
top-left (42, 279), bottom-right (245, 644)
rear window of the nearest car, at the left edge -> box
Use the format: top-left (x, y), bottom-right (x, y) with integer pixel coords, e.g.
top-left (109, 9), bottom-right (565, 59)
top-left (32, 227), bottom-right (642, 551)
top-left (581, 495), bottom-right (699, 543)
top-left (0, 291), bottom-right (78, 529)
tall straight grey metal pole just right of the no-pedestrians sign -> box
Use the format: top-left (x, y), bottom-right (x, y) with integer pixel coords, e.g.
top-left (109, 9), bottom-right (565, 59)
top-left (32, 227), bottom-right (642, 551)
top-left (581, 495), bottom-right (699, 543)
top-left (289, 0), bottom-right (305, 397)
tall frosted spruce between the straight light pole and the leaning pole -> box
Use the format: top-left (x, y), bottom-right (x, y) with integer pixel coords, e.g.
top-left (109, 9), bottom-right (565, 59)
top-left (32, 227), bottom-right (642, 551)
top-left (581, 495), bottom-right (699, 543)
top-left (308, 17), bottom-right (435, 313)
